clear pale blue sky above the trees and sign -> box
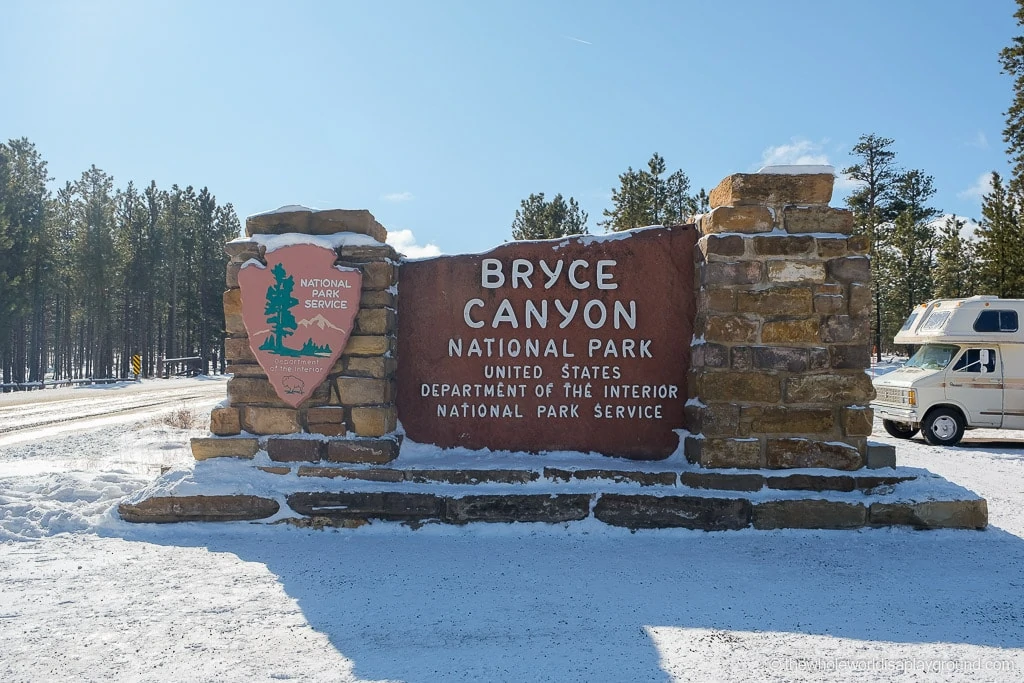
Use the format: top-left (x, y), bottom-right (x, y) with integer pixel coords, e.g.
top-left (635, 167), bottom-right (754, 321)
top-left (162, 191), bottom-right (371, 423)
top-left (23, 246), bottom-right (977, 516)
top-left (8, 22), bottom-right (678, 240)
top-left (0, 0), bottom-right (1017, 253)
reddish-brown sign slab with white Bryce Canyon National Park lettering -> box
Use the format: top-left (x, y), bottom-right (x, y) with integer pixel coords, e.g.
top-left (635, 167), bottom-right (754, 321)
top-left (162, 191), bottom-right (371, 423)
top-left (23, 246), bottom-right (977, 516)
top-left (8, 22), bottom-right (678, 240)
top-left (397, 225), bottom-right (697, 460)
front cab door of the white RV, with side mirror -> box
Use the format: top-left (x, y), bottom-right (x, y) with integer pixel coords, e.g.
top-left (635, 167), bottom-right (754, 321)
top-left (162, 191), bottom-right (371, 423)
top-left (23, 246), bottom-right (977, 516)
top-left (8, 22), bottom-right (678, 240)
top-left (946, 346), bottom-right (1002, 427)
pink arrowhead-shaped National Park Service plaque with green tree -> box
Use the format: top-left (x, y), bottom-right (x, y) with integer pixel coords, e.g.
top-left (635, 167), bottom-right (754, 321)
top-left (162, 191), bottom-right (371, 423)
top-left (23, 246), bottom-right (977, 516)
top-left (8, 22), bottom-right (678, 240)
top-left (239, 244), bottom-right (362, 408)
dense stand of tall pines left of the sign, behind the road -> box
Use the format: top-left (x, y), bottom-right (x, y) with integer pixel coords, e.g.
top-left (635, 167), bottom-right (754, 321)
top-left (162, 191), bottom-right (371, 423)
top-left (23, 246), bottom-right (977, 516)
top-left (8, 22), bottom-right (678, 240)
top-left (0, 138), bottom-right (240, 385)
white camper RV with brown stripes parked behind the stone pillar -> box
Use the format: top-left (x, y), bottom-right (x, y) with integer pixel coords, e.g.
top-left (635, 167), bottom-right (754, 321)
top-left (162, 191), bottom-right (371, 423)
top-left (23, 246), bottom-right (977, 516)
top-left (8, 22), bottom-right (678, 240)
top-left (871, 296), bottom-right (1024, 445)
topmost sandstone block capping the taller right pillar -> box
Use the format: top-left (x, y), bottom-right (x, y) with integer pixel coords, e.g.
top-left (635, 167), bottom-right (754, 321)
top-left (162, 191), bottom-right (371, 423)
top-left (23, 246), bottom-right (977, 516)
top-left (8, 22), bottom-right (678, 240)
top-left (708, 173), bottom-right (836, 209)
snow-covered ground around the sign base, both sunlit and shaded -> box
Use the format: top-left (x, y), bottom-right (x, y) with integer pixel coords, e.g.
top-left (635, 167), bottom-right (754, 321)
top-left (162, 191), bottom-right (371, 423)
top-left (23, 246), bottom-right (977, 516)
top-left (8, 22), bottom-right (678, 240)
top-left (0, 380), bottom-right (1024, 682)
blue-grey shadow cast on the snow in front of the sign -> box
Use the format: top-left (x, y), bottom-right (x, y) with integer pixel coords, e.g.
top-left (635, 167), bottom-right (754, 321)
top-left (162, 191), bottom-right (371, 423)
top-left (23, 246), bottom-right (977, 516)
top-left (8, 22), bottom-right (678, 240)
top-left (105, 523), bottom-right (1024, 681)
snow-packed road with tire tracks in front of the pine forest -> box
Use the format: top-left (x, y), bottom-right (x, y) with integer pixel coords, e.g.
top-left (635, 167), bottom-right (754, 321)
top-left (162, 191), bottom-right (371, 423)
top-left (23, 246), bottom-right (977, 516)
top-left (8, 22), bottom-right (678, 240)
top-left (0, 377), bottom-right (224, 446)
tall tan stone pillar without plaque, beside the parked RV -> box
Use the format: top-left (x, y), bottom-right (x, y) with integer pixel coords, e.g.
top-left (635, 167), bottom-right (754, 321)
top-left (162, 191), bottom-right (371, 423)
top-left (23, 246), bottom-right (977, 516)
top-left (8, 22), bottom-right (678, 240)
top-left (686, 173), bottom-right (874, 470)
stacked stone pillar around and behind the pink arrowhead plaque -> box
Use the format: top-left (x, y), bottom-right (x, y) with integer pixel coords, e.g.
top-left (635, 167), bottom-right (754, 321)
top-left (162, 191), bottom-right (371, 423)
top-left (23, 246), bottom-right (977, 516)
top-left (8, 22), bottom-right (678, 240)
top-left (193, 207), bottom-right (398, 461)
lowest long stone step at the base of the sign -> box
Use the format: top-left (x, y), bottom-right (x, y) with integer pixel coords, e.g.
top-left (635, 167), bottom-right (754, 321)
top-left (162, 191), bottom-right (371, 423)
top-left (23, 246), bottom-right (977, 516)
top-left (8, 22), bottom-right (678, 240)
top-left (119, 489), bottom-right (988, 531)
